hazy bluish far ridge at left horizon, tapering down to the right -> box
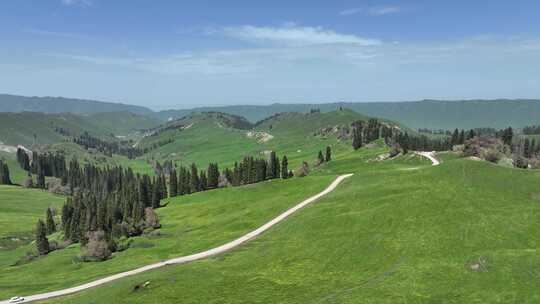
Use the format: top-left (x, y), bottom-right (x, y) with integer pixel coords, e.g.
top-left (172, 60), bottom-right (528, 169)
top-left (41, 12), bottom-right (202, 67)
top-left (0, 94), bottom-right (152, 115)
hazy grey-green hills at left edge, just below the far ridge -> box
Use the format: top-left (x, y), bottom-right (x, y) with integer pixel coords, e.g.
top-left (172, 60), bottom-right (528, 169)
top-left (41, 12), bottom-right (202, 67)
top-left (0, 112), bottom-right (158, 146)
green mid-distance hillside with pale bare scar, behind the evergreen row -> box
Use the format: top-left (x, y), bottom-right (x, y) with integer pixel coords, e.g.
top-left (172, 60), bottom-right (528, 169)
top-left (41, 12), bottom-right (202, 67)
top-left (140, 110), bottom-right (384, 168)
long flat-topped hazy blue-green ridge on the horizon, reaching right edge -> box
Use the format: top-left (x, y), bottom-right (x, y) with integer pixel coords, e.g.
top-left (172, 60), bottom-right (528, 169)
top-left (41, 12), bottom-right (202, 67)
top-left (157, 100), bottom-right (540, 129)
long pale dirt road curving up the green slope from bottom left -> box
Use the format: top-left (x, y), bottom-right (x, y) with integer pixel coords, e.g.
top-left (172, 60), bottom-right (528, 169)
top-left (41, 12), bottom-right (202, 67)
top-left (0, 174), bottom-right (352, 304)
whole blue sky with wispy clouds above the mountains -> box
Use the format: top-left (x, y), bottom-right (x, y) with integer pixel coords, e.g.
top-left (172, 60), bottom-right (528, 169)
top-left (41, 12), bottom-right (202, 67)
top-left (0, 0), bottom-right (540, 109)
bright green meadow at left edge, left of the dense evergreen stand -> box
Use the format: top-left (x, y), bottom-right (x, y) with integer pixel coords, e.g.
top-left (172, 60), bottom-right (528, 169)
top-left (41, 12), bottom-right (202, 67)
top-left (0, 186), bottom-right (65, 241)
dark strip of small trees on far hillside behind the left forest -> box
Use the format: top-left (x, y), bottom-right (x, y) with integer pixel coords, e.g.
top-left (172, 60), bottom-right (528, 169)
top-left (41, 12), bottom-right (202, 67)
top-left (73, 132), bottom-right (144, 159)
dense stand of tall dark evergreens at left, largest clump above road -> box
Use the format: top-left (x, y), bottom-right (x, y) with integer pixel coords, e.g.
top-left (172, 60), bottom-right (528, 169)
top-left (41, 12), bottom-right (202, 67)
top-left (57, 160), bottom-right (167, 251)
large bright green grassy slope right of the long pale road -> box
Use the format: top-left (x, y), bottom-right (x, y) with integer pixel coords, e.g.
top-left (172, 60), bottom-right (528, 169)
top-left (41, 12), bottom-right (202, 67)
top-left (45, 150), bottom-right (540, 303)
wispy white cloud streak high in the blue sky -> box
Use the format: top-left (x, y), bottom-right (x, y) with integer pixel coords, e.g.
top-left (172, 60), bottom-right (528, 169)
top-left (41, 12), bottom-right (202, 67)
top-left (218, 24), bottom-right (381, 46)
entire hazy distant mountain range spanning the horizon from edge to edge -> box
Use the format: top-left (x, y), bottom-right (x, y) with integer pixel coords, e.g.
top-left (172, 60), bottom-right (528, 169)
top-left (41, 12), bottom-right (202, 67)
top-left (0, 94), bottom-right (540, 129)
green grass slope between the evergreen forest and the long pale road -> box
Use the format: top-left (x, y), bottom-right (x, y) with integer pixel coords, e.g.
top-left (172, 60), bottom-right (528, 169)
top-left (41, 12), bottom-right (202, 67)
top-left (0, 175), bottom-right (334, 299)
